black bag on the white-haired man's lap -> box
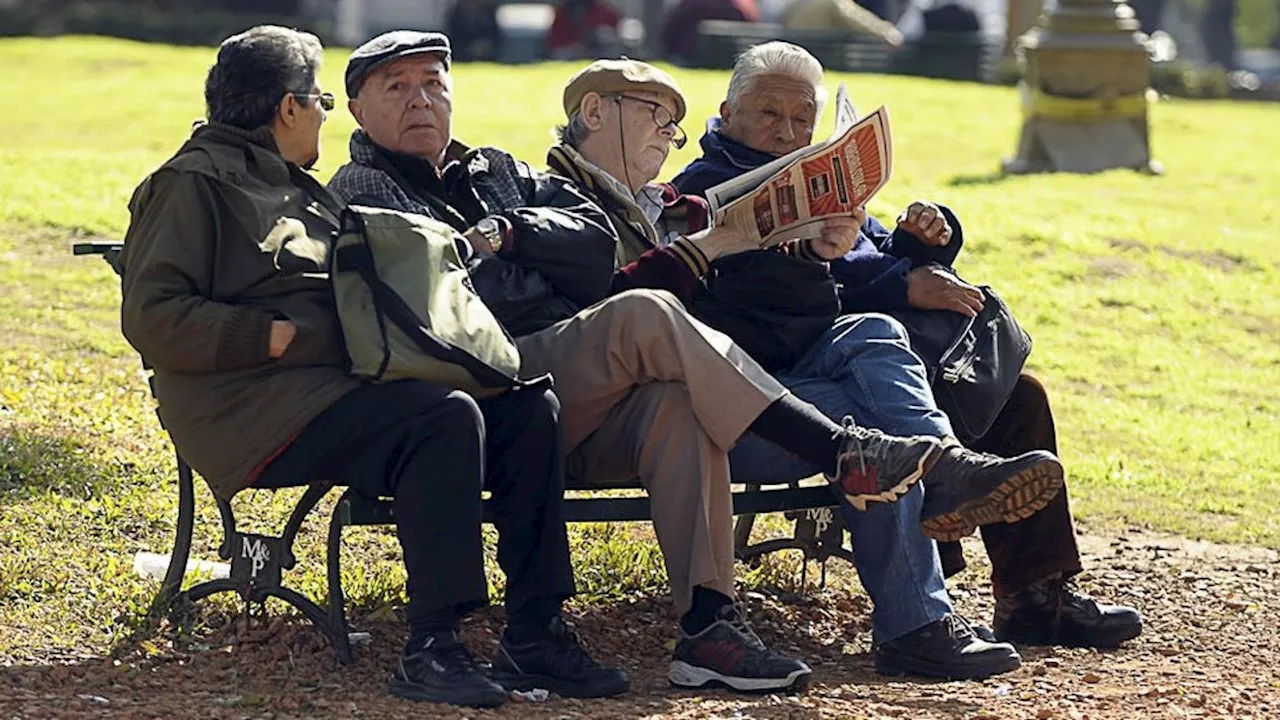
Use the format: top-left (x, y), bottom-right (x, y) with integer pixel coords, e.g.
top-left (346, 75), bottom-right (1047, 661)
top-left (891, 286), bottom-right (1032, 443)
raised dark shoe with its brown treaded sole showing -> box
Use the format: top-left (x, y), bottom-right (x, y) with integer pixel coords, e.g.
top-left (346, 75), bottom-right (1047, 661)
top-left (920, 442), bottom-right (1065, 542)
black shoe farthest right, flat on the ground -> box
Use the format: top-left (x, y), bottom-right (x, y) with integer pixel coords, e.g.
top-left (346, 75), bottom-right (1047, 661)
top-left (993, 578), bottom-right (1142, 647)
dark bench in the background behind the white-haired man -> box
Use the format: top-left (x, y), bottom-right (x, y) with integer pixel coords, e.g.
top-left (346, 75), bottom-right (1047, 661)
top-left (694, 20), bottom-right (1001, 82)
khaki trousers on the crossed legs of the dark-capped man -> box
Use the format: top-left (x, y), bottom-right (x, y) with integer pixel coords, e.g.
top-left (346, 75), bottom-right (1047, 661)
top-left (517, 290), bottom-right (787, 612)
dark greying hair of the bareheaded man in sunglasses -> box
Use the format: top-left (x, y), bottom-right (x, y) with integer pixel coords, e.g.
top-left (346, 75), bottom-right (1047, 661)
top-left (205, 26), bottom-right (324, 129)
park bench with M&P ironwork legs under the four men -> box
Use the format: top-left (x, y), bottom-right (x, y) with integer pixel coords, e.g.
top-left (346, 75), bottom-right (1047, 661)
top-left (72, 242), bottom-right (852, 664)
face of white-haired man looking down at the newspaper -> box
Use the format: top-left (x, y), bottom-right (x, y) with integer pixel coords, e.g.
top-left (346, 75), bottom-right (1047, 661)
top-left (721, 74), bottom-right (818, 155)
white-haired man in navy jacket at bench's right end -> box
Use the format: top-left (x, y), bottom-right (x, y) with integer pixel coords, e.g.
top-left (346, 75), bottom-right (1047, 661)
top-left (673, 42), bottom-right (1142, 647)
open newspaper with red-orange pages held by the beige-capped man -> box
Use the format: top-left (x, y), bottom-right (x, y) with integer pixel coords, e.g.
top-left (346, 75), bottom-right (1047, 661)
top-left (707, 83), bottom-right (893, 247)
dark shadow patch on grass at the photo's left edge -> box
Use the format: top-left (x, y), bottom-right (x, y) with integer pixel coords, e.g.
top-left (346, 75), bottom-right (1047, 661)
top-left (0, 427), bottom-right (132, 498)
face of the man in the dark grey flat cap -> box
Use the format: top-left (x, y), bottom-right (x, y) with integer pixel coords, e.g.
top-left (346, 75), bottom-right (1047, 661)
top-left (348, 55), bottom-right (453, 167)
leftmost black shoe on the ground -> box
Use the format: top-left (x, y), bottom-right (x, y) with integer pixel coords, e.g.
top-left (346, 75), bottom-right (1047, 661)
top-left (390, 633), bottom-right (507, 707)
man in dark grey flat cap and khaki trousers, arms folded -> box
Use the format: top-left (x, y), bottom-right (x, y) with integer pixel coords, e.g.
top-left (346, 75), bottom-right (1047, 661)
top-left (330, 31), bottom-right (1059, 691)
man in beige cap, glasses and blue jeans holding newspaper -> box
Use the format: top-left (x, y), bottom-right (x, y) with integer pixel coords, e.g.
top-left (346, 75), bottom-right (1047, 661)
top-left (548, 59), bottom-right (1090, 678)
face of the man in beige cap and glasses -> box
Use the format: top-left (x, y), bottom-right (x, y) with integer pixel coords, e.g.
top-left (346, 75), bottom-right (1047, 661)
top-left (602, 91), bottom-right (677, 183)
